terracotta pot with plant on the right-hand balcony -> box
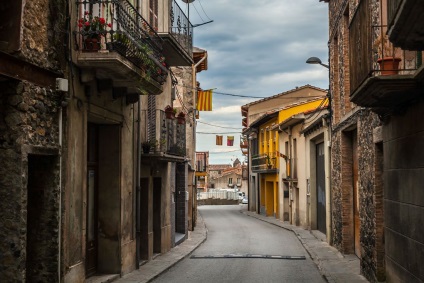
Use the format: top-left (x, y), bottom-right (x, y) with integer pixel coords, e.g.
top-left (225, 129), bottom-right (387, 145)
top-left (374, 34), bottom-right (401, 76)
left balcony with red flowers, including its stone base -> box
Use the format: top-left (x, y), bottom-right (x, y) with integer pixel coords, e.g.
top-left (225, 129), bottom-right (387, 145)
top-left (74, 0), bottom-right (168, 94)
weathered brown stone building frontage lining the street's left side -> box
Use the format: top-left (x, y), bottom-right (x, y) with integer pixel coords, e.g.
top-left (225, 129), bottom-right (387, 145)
top-left (0, 0), bottom-right (202, 282)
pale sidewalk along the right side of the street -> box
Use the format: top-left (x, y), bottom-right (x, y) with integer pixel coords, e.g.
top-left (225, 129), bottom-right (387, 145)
top-left (242, 210), bottom-right (368, 283)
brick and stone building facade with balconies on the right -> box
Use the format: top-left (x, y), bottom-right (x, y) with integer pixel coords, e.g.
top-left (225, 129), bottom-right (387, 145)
top-left (325, 0), bottom-right (423, 282)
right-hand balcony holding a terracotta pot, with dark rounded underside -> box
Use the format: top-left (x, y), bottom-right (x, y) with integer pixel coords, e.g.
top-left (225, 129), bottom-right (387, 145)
top-left (349, 1), bottom-right (422, 114)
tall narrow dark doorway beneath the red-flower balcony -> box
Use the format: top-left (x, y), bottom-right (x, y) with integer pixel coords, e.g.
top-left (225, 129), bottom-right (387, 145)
top-left (85, 124), bottom-right (98, 277)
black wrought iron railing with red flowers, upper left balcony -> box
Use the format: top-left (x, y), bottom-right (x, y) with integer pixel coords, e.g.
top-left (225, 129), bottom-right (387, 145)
top-left (74, 0), bottom-right (168, 84)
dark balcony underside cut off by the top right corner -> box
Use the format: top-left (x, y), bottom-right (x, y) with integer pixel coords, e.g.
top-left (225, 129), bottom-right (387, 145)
top-left (387, 0), bottom-right (424, 50)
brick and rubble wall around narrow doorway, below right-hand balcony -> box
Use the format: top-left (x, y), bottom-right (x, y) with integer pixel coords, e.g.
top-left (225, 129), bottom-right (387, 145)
top-left (328, 0), bottom-right (384, 282)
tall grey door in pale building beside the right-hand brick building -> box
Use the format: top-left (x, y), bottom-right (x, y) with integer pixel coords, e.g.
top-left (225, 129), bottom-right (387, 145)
top-left (316, 143), bottom-right (326, 234)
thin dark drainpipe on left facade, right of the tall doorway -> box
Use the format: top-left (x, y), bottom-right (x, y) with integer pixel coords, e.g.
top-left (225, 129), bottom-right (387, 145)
top-left (135, 98), bottom-right (141, 269)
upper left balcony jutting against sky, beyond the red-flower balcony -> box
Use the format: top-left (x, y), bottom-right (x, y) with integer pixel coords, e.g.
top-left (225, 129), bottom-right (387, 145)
top-left (158, 0), bottom-right (193, 66)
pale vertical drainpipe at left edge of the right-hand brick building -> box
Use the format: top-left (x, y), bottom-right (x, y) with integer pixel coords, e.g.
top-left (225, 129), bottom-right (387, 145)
top-left (322, 118), bottom-right (332, 245)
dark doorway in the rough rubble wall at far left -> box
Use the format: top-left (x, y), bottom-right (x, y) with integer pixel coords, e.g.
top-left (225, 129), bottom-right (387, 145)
top-left (26, 155), bottom-right (59, 282)
